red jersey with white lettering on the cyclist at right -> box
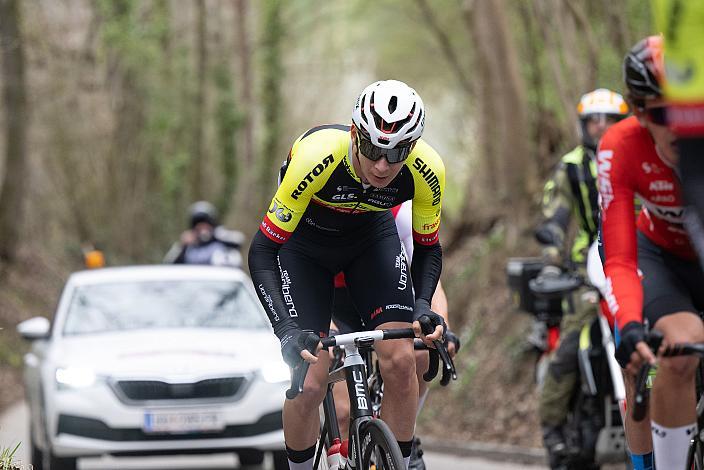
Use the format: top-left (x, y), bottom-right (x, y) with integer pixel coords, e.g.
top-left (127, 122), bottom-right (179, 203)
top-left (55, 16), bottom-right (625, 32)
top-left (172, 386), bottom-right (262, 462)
top-left (597, 117), bottom-right (695, 327)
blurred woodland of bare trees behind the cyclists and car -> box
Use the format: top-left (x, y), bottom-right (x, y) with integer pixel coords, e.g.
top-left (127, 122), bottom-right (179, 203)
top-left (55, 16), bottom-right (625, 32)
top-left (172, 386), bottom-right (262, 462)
top-left (0, 0), bottom-right (651, 442)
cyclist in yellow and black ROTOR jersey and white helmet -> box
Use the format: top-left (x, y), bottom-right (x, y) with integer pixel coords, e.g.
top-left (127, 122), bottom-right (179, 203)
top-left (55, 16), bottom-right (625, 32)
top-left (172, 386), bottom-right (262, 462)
top-left (249, 80), bottom-right (445, 470)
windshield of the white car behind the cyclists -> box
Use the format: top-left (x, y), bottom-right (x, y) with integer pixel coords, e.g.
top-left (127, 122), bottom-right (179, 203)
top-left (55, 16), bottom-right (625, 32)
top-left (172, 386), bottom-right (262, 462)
top-left (64, 280), bottom-right (267, 335)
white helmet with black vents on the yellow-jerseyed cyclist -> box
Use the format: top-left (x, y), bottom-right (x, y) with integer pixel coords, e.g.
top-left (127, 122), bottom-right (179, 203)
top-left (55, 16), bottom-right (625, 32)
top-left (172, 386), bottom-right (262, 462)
top-left (352, 80), bottom-right (425, 149)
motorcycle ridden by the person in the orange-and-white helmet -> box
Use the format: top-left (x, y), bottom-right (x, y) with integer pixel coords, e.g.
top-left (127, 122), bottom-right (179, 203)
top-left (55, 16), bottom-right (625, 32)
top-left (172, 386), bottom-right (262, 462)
top-left (509, 244), bottom-right (630, 470)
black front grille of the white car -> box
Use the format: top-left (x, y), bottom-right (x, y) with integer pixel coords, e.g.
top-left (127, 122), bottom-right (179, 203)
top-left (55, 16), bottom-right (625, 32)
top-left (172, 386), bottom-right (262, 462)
top-left (116, 377), bottom-right (247, 402)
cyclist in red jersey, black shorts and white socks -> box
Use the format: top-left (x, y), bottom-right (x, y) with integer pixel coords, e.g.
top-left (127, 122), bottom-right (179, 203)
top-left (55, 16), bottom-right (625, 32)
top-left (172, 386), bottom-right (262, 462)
top-left (597, 36), bottom-right (704, 469)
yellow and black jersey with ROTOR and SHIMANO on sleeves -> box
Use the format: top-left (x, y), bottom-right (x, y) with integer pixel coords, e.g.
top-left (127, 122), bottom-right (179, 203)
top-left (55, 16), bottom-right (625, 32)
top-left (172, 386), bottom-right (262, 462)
top-left (260, 124), bottom-right (445, 245)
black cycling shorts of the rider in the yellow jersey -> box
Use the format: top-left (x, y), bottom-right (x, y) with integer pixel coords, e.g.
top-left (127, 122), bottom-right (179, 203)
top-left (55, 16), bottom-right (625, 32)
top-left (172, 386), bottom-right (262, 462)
top-left (279, 212), bottom-right (415, 335)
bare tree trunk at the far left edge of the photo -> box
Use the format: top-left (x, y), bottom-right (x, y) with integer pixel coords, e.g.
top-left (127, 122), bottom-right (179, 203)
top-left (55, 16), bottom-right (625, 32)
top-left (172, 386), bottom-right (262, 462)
top-left (0, 0), bottom-right (27, 263)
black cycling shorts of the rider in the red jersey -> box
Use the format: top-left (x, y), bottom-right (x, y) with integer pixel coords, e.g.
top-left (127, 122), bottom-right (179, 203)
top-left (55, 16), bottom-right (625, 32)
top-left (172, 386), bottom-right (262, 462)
top-left (638, 231), bottom-right (704, 327)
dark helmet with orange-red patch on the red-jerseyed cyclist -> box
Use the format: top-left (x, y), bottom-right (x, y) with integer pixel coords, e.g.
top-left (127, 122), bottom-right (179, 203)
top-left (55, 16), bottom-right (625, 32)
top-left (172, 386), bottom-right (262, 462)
top-left (623, 36), bottom-right (663, 106)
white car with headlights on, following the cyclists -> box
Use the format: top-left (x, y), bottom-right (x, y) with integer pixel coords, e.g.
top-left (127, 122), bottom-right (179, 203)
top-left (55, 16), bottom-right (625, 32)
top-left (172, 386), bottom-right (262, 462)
top-left (17, 265), bottom-right (290, 470)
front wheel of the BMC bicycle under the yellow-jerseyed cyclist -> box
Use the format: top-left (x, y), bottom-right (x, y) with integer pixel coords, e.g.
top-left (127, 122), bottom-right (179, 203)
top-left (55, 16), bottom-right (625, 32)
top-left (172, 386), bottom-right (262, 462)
top-left (359, 419), bottom-right (406, 470)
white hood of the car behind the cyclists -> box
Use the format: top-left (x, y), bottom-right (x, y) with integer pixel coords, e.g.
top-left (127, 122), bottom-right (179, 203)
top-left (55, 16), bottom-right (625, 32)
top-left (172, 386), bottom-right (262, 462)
top-left (51, 329), bottom-right (282, 381)
